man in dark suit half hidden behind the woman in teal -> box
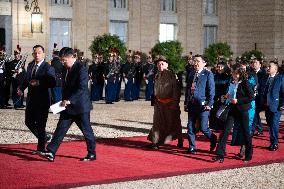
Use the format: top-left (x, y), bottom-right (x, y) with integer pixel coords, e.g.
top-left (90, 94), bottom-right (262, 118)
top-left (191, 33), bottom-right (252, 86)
top-left (250, 58), bottom-right (266, 136)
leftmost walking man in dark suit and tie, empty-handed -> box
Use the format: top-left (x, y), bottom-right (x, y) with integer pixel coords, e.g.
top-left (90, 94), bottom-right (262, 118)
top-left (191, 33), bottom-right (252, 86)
top-left (18, 45), bottom-right (55, 154)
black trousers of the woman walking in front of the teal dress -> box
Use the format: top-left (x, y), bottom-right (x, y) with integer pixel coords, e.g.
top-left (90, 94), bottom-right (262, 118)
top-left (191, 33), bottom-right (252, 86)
top-left (216, 106), bottom-right (253, 160)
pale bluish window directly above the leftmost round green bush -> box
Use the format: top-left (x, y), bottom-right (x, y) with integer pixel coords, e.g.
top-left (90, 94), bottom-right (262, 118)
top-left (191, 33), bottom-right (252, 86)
top-left (109, 20), bottom-right (128, 42)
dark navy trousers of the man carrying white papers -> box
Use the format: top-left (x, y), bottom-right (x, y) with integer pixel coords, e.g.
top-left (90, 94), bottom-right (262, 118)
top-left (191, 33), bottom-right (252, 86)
top-left (46, 112), bottom-right (96, 155)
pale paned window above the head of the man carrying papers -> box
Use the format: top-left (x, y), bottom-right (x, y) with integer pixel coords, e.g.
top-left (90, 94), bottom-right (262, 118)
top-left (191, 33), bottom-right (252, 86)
top-left (49, 19), bottom-right (71, 52)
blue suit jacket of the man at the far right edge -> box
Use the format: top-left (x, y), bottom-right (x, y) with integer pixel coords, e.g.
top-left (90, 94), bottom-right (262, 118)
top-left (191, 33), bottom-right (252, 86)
top-left (262, 74), bottom-right (284, 112)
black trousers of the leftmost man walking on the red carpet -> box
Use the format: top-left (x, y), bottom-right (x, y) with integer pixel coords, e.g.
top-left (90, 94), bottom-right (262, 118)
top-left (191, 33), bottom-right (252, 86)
top-left (25, 106), bottom-right (48, 151)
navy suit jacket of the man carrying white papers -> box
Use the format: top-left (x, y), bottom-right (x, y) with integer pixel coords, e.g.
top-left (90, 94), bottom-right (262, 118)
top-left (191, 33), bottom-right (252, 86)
top-left (62, 61), bottom-right (92, 115)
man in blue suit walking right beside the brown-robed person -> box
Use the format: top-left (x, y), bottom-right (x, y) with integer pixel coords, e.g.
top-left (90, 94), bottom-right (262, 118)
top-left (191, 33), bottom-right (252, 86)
top-left (185, 55), bottom-right (217, 154)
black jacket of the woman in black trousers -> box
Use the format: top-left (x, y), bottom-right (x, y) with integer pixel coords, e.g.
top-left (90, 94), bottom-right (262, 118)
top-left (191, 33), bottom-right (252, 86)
top-left (235, 80), bottom-right (254, 111)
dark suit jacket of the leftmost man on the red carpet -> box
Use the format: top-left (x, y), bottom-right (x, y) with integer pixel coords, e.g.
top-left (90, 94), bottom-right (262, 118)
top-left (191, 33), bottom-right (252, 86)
top-left (20, 61), bottom-right (56, 110)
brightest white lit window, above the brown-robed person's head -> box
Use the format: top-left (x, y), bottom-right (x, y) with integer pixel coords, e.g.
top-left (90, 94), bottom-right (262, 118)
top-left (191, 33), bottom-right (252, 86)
top-left (159, 24), bottom-right (176, 42)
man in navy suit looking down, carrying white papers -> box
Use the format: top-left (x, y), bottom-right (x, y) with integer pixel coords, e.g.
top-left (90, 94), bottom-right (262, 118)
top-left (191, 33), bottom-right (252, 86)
top-left (40, 47), bottom-right (96, 161)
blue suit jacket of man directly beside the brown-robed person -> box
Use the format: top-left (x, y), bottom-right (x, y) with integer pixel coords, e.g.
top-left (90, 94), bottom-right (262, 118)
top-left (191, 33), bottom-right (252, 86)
top-left (185, 69), bottom-right (215, 110)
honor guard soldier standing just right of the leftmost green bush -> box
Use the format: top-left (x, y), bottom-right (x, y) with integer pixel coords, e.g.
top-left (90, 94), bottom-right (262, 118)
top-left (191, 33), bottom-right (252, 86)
top-left (122, 50), bottom-right (136, 101)
